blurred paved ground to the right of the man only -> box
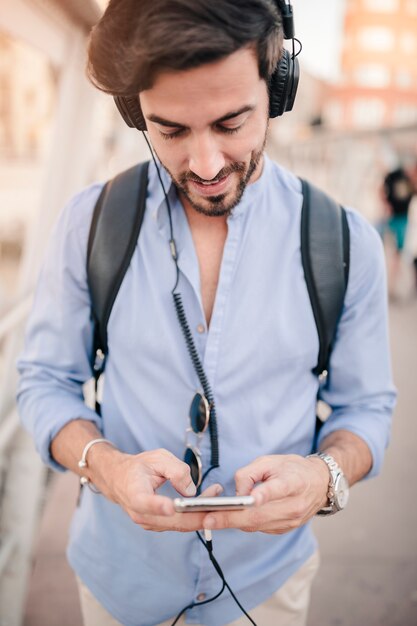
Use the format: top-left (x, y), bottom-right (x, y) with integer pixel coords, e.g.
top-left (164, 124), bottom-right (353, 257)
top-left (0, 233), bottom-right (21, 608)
top-left (309, 300), bottom-right (417, 626)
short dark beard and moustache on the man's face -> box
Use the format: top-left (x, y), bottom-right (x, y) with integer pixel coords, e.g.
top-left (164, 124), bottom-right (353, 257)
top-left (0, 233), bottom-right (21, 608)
top-left (162, 135), bottom-right (266, 217)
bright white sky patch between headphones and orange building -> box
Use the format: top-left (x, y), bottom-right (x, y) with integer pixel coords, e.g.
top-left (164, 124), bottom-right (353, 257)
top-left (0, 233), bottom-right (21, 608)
top-left (292, 0), bottom-right (347, 80)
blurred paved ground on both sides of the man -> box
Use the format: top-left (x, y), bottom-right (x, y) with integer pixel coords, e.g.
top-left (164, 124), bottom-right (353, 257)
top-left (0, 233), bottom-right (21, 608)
top-left (24, 299), bottom-right (417, 626)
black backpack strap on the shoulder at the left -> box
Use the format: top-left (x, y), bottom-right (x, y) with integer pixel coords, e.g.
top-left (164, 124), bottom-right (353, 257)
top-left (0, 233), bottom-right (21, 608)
top-left (87, 161), bottom-right (149, 381)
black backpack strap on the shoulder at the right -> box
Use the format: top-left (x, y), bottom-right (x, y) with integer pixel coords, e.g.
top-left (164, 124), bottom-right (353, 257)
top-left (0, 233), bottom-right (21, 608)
top-left (301, 180), bottom-right (350, 376)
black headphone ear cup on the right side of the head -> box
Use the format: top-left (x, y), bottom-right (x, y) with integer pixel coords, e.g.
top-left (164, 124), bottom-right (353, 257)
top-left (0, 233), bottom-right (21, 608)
top-left (269, 48), bottom-right (300, 117)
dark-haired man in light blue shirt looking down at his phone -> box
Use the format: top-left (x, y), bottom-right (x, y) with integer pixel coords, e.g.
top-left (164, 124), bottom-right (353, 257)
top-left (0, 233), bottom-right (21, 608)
top-left (19, 0), bottom-right (395, 626)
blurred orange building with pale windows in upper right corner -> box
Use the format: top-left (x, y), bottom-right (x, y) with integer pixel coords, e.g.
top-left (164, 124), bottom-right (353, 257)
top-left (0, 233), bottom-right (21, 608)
top-left (323, 0), bottom-right (417, 129)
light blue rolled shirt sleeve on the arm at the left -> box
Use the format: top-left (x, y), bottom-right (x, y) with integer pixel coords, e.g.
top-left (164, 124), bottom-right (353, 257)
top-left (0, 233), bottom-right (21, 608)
top-left (17, 185), bottom-right (101, 470)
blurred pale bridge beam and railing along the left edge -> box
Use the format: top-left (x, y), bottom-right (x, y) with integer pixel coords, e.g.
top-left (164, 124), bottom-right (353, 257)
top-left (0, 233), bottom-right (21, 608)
top-left (0, 0), bottom-right (104, 626)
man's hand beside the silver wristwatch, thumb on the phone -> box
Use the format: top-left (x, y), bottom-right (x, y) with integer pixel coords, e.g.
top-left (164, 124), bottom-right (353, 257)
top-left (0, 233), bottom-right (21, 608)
top-left (203, 455), bottom-right (329, 534)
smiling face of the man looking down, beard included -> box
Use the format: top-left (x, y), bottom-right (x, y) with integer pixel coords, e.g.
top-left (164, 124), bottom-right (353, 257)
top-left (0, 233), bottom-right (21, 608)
top-left (140, 48), bottom-right (269, 216)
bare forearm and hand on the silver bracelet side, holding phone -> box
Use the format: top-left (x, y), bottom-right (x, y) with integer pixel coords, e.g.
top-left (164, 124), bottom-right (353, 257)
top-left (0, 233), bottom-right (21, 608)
top-left (51, 419), bottom-right (222, 532)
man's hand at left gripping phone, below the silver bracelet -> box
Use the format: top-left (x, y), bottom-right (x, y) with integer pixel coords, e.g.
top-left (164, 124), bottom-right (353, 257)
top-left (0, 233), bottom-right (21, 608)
top-left (103, 449), bottom-right (223, 532)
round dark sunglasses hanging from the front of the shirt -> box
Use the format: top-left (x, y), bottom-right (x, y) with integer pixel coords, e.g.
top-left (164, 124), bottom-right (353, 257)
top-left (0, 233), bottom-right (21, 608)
top-left (184, 393), bottom-right (210, 488)
